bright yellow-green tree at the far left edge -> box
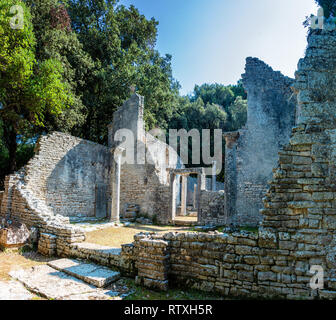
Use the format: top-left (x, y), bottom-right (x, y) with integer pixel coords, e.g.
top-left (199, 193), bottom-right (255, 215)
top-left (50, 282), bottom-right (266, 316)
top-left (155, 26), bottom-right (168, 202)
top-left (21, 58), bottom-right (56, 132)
top-left (0, 0), bottom-right (73, 172)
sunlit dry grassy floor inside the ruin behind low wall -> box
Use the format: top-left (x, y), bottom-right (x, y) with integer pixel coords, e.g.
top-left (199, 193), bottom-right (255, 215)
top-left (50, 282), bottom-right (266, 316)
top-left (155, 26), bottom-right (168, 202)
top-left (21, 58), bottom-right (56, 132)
top-left (86, 224), bottom-right (191, 248)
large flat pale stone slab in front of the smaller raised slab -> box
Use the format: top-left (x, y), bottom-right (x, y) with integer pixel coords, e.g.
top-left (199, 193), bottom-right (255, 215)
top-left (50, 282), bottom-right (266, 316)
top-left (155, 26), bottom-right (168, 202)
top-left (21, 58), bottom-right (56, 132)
top-left (9, 265), bottom-right (121, 300)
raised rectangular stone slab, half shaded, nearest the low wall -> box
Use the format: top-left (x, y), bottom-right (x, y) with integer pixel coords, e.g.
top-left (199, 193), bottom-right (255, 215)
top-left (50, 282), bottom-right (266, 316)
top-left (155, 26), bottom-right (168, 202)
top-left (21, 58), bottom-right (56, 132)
top-left (48, 259), bottom-right (120, 288)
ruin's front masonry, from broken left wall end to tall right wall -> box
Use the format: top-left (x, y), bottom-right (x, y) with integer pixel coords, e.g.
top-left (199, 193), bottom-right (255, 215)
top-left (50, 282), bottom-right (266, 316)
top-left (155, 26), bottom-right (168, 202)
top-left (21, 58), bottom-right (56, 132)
top-left (1, 25), bottom-right (336, 299)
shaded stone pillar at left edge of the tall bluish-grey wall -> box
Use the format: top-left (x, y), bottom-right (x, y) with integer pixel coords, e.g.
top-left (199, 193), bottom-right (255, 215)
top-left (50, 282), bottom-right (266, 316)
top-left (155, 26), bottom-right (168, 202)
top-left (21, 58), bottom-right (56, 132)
top-left (224, 132), bottom-right (239, 224)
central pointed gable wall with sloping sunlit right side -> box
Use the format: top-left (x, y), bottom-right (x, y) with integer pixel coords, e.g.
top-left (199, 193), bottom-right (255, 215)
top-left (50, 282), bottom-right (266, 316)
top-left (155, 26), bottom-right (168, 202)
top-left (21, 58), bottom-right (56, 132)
top-left (109, 94), bottom-right (183, 224)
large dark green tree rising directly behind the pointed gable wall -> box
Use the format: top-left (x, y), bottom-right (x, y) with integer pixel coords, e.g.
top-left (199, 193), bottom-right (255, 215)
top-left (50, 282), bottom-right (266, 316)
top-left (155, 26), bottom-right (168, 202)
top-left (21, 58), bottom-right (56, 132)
top-left (69, 0), bottom-right (179, 143)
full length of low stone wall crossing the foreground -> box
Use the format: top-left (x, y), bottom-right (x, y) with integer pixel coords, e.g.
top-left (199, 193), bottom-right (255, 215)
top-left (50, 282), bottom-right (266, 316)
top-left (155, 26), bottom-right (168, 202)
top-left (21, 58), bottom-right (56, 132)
top-left (34, 221), bottom-right (336, 299)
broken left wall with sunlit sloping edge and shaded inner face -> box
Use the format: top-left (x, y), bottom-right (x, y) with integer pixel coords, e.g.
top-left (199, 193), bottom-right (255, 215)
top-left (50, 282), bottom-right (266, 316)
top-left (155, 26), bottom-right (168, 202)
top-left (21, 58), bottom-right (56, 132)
top-left (0, 132), bottom-right (114, 254)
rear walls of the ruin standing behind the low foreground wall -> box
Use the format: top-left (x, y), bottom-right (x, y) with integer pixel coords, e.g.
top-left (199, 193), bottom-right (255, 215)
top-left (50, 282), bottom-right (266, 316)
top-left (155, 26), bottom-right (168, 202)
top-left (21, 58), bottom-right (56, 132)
top-left (1, 58), bottom-right (295, 229)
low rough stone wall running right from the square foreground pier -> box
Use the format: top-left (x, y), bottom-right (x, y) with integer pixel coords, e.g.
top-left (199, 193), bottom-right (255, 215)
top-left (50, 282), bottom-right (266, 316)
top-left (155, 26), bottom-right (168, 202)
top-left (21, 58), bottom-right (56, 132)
top-left (134, 231), bottom-right (336, 299)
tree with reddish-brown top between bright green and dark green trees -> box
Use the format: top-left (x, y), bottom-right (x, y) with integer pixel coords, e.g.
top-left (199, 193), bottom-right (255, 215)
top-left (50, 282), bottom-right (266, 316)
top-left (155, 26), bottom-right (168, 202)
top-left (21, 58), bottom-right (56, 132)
top-left (25, 0), bottom-right (94, 135)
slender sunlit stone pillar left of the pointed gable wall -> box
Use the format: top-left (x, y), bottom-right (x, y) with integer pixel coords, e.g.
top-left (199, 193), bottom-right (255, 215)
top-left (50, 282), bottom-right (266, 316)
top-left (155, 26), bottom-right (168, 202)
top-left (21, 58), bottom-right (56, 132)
top-left (110, 148), bottom-right (125, 223)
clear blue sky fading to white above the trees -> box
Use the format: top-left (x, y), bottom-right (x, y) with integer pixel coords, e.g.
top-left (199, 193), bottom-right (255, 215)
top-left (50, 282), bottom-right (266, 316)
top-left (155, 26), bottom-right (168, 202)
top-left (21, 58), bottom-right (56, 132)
top-left (121, 0), bottom-right (317, 94)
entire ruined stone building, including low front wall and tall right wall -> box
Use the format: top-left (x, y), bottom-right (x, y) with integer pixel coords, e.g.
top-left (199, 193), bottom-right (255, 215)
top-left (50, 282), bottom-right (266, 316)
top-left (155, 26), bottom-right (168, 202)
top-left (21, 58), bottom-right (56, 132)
top-left (1, 25), bottom-right (336, 299)
